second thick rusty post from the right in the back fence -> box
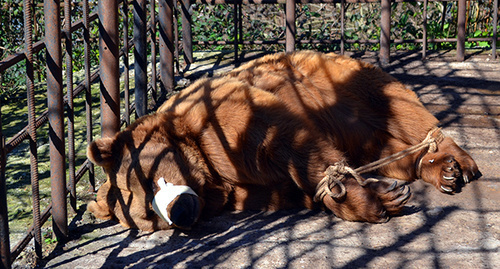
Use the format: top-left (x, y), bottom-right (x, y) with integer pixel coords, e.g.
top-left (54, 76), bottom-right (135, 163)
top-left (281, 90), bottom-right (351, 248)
top-left (379, 0), bottom-right (391, 66)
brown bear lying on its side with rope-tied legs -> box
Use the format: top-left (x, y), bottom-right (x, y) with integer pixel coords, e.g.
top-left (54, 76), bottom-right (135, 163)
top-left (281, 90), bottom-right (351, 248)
top-left (88, 52), bottom-right (479, 231)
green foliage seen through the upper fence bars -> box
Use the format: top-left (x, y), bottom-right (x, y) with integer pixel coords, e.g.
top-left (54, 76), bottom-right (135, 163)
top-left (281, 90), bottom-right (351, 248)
top-left (0, 0), bottom-right (493, 100)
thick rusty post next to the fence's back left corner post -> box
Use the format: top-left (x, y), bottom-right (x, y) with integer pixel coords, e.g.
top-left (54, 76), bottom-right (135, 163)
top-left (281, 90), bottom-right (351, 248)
top-left (158, 0), bottom-right (174, 95)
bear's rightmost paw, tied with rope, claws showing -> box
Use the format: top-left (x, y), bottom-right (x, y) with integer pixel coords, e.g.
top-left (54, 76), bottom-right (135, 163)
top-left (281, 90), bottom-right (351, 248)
top-left (421, 137), bottom-right (480, 194)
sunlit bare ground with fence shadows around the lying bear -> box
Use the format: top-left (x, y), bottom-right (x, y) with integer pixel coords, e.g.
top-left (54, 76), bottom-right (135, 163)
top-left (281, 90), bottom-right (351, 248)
top-left (13, 49), bottom-right (500, 269)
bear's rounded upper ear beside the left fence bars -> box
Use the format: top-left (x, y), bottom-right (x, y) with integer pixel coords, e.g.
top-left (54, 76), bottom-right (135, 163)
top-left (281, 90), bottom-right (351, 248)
top-left (87, 137), bottom-right (119, 168)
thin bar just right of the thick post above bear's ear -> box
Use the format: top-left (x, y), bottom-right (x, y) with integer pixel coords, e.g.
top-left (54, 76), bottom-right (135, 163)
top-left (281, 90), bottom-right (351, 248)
top-left (122, 1), bottom-right (130, 126)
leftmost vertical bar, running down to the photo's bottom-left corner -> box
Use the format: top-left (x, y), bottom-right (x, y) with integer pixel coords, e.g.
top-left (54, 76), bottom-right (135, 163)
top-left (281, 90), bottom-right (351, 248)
top-left (0, 105), bottom-right (11, 269)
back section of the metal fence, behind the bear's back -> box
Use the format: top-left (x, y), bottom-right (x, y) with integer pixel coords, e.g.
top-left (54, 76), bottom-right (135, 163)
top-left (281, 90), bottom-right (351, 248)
top-left (184, 0), bottom-right (498, 65)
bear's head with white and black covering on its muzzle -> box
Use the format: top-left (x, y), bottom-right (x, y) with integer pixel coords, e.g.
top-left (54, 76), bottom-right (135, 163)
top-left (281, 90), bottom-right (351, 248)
top-left (87, 115), bottom-right (203, 228)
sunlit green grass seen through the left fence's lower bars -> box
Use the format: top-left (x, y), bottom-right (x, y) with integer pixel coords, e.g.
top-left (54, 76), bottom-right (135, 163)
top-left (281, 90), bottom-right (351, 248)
top-left (1, 65), bottom-right (133, 247)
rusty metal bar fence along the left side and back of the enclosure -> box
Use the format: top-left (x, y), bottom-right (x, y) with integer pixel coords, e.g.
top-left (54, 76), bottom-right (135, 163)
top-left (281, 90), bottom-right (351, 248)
top-left (0, 0), bottom-right (498, 268)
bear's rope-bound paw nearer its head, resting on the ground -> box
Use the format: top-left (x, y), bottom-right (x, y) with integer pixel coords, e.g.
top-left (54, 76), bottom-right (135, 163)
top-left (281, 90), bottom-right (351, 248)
top-left (323, 177), bottom-right (410, 223)
